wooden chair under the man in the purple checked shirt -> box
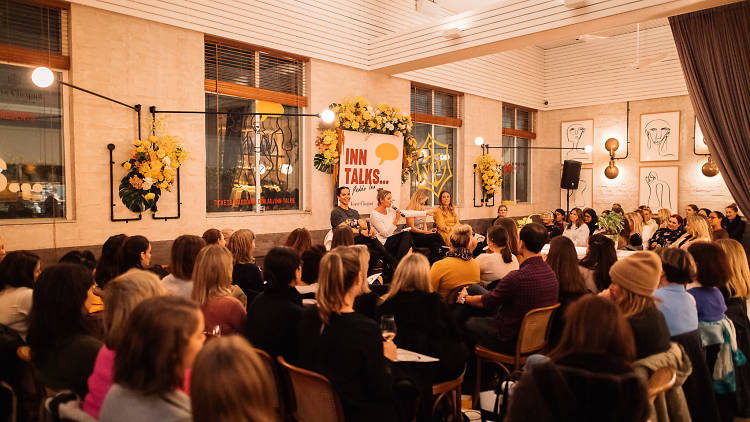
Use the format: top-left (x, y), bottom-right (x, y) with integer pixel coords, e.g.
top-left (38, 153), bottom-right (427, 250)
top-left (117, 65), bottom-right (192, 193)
top-left (474, 303), bottom-right (560, 408)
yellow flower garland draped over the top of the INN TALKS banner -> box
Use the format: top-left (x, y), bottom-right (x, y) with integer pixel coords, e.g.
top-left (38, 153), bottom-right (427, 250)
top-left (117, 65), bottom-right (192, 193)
top-left (313, 96), bottom-right (419, 182)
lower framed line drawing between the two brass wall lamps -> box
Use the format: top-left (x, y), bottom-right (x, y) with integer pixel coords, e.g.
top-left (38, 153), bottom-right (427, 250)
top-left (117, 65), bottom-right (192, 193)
top-left (638, 166), bottom-right (680, 213)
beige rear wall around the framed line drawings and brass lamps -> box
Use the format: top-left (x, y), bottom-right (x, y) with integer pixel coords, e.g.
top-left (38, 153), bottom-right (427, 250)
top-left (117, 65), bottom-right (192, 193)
top-left (539, 96), bottom-right (733, 214)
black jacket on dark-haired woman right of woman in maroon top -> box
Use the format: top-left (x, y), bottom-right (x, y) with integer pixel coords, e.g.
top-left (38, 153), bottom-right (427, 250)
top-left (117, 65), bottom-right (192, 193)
top-left (245, 284), bottom-right (302, 363)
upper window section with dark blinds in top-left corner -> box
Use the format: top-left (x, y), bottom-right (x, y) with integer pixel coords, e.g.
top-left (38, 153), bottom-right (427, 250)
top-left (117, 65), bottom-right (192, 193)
top-left (0, 0), bottom-right (70, 69)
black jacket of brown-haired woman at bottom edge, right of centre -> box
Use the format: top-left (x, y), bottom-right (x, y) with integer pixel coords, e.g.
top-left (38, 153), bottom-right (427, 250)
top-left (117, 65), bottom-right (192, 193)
top-left (505, 354), bottom-right (649, 422)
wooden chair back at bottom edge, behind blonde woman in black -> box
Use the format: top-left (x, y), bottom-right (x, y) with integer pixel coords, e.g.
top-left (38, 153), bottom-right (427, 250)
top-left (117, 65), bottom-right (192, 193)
top-left (277, 356), bottom-right (345, 422)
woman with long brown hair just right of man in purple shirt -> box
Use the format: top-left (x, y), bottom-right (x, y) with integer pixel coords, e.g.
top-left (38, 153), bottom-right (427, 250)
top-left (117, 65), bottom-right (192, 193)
top-left (547, 236), bottom-right (587, 347)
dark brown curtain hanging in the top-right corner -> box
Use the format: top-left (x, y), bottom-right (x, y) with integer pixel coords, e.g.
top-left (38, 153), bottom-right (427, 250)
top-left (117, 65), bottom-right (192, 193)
top-left (669, 1), bottom-right (750, 216)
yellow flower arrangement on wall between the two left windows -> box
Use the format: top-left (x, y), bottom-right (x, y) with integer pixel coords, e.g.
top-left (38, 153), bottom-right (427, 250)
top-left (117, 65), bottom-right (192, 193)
top-left (119, 120), bottom-right (188, 212)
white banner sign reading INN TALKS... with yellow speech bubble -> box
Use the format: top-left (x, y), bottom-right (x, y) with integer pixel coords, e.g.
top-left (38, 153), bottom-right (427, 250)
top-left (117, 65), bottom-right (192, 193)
top-left (339, 130), bottom-right (404, 210)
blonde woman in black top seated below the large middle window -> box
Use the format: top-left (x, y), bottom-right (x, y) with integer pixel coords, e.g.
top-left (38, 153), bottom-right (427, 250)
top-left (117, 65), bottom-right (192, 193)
top-left (227, 229), bottom-right (263, 301)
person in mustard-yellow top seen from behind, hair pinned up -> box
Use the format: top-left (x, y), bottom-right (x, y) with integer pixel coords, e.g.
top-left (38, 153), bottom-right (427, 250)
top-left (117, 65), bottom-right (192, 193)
top-left (430, 224), bottom-right (480, 300)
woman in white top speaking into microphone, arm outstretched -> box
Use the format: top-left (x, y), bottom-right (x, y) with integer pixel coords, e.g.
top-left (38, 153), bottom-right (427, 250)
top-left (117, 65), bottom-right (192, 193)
top-left (370, 188), bottom-right (418, 261)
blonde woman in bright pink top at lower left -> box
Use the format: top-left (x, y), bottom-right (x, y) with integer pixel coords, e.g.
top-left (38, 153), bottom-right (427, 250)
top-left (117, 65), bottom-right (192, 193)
top-left (83, 270), bottom-right (166, 419)
